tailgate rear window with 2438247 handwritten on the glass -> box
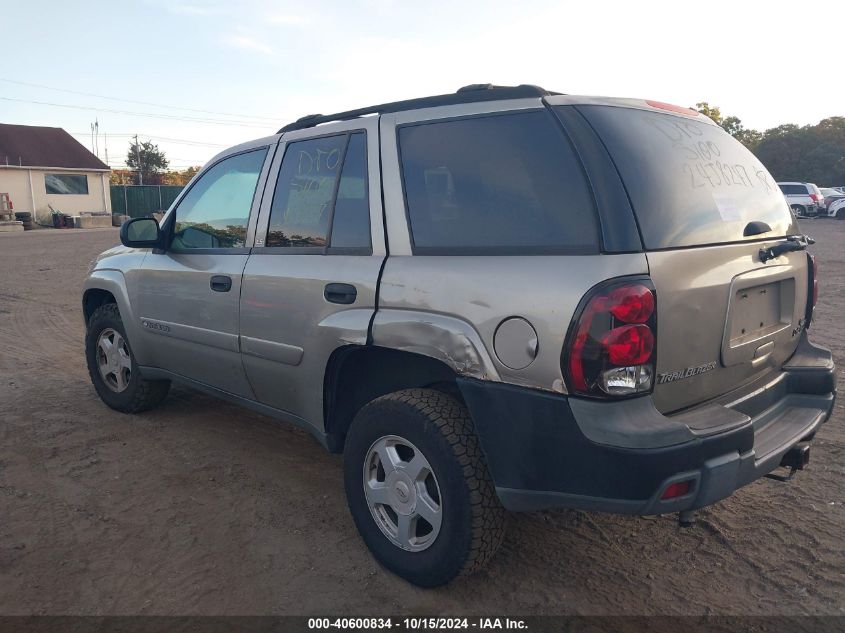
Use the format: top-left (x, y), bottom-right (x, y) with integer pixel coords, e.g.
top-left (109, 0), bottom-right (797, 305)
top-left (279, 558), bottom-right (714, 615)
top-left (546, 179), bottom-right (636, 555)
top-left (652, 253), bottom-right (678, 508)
top-left (578, 106), bottom-right (792, 250)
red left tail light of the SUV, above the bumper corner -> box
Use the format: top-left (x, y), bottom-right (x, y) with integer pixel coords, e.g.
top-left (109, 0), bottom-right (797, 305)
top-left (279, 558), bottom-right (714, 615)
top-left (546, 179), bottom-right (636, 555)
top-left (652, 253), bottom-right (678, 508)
top-left (563, 278), bottom-right (657, 398)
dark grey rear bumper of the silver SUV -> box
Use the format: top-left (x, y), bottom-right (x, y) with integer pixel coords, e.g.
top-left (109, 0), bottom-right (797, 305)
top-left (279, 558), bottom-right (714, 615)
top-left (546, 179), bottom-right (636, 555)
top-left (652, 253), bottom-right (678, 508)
top-left (459, 332), bottom-right (836, 515)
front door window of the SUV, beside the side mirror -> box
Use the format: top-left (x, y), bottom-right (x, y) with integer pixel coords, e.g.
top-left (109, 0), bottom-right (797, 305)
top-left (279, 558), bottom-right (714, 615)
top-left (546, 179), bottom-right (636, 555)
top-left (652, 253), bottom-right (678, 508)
top-left (172, 148), bottom-right (267, 249)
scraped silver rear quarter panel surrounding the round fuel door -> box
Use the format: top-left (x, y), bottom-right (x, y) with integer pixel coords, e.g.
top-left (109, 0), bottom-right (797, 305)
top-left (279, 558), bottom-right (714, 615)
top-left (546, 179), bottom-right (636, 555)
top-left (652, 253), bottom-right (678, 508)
top-left (373, 253), bottom-right (648, 392)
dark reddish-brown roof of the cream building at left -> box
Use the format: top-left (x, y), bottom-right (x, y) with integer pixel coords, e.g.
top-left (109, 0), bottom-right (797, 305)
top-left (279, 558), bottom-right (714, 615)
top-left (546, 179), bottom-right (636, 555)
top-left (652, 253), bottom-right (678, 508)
top-left (0, 123), bottom-right (109, 170)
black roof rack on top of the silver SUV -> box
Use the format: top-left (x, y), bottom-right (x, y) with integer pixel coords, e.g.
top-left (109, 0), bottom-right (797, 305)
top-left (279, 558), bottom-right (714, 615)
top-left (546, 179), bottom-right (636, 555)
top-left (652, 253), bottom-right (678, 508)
top-left (278, 84), bottom-right (560, 134)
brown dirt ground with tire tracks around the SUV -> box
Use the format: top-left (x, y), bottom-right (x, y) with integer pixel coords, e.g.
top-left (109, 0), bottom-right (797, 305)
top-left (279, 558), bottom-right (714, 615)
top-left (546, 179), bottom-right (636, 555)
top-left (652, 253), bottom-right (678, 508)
top-left (0, 220), bottom-right (845, 615)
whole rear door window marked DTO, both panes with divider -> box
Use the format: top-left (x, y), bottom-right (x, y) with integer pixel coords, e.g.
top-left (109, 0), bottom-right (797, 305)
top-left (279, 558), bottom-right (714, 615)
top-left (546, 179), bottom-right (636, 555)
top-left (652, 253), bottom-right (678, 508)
top-left (266, 132), bottom-right (370, 252)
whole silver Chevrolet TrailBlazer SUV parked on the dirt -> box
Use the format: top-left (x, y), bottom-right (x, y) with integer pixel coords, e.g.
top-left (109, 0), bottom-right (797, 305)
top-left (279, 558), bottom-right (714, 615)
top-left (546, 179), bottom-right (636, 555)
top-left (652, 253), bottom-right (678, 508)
top-left (83, 85), bottom-right (835, 586)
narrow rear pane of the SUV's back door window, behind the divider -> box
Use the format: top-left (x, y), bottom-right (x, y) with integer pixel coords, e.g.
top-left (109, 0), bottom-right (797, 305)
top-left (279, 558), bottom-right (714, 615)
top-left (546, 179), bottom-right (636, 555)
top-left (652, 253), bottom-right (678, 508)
top-left (329, 132), bottom-right (371, 248)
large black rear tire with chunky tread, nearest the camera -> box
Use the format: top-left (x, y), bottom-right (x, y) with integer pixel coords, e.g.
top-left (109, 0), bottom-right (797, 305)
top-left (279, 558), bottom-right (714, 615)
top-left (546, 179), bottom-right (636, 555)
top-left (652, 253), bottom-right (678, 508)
top-left (344, 389), bottom-right (506, 587)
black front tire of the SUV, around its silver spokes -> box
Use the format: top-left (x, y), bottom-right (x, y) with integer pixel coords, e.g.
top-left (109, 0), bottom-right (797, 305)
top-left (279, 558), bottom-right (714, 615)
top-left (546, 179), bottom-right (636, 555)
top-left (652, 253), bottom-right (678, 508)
top-left (85, 303), bottom-right (170, 413)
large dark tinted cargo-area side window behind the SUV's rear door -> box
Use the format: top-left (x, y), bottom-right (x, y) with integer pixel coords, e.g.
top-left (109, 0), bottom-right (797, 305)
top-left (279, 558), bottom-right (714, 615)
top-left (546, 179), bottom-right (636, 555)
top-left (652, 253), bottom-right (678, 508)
top-left (398, 110), bottom-right (598, 254)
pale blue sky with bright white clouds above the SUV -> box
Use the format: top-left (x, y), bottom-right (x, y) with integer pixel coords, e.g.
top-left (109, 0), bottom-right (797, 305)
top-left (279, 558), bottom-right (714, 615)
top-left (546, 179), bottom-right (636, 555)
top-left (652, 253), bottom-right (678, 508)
top-left (0, 0), bottom-right (845, 168)
